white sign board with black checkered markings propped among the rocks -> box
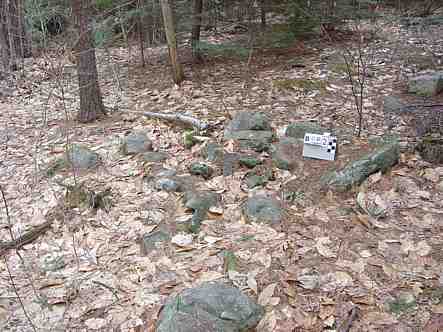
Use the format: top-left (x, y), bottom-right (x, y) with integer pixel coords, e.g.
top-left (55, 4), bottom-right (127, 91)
top-left (303, 133), bottom-right (337, 160)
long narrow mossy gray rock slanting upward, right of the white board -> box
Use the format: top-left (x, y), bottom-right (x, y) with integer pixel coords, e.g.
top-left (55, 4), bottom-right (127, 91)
top-left (320, 142), bottom-right (400, 192)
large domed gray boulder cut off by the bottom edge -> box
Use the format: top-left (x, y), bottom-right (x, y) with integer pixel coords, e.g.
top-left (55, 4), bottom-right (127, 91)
top-left (156, 282), bottom-right (264, 332)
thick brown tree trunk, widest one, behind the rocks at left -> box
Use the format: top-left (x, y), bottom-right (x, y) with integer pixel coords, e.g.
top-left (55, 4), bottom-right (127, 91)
top-left (72, 0), bottom-right (106, 123)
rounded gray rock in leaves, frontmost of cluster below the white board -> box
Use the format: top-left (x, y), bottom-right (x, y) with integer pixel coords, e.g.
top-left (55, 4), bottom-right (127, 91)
top-left (243, 196), bottom-right (283, 224)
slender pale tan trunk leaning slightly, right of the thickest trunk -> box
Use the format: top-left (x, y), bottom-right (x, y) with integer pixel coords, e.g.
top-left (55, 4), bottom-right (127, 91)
top-left (160, 0), bottom-right (184, 84)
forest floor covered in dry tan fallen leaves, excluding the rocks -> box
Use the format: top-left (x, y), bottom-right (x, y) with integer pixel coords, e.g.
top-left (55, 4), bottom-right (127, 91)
top-left (0, 13), bottom-right (443, 332)
